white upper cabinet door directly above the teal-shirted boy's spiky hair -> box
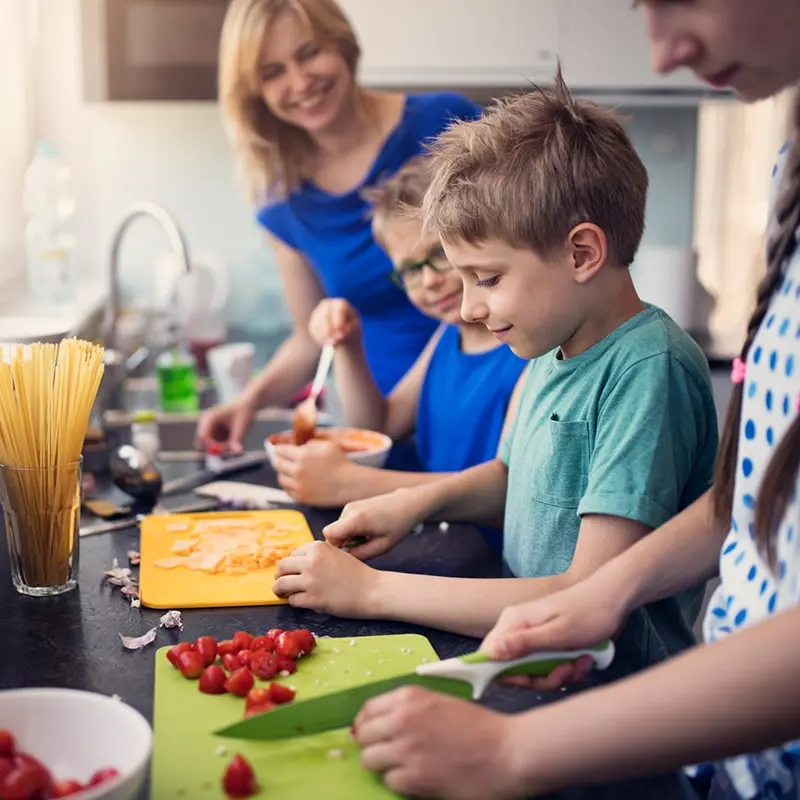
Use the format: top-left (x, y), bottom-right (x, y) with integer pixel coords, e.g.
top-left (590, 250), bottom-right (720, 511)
top-left (339, 0), bottom-right (560, 86)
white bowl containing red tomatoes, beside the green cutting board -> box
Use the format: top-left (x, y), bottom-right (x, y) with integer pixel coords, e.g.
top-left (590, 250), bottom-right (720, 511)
top-left (0, 689), bottom-right (153, 800)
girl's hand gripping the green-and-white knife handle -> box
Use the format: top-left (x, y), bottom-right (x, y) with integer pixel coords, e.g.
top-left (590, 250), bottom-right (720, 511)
top-left (481, 578), bottom-right (624, 691)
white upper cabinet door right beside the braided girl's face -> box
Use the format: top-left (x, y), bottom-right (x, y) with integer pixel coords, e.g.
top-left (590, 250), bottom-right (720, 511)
top-left (560, 0), bottom-right (708, 89)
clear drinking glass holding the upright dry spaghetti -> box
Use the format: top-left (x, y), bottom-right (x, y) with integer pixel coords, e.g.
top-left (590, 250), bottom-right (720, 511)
top-left (0, 460), bottom-right (81, 597)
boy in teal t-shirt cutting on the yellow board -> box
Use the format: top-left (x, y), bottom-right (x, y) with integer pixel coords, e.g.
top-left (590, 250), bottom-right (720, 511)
top-left (274, 75), bottom-right (717, 668)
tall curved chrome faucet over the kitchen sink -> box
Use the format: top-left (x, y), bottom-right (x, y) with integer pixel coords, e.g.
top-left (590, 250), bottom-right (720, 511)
top-left (95, 202), bottom-right (191, 418)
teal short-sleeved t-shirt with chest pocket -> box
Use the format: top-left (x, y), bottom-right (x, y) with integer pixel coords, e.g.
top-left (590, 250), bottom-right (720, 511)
top-left (501, 306), bottom-right (718, 663)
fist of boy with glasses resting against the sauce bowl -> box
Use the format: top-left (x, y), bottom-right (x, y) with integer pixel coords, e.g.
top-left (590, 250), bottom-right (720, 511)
top-left (273, 439), bottom-right (356, 508)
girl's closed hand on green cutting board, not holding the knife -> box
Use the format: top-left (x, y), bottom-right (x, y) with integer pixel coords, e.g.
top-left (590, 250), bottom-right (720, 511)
top-left (353, 686), bottom-right (525, 800)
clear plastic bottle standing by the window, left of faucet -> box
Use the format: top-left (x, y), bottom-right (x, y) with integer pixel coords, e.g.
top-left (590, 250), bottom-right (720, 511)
top-left (23, 142), bottom-right (75, 305)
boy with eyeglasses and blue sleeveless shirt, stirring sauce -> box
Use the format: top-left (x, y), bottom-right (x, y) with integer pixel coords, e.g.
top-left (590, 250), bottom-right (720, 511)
top-left (275, 156), bottom-right (526, 548)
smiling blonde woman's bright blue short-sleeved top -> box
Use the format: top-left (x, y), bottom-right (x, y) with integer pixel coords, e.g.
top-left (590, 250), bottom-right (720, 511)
top-left (257, 92), bottom-right (481, 395)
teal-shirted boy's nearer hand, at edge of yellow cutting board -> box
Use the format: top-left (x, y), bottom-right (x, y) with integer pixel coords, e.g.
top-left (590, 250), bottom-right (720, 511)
top-left (272, 542), bottom-right (379, 617)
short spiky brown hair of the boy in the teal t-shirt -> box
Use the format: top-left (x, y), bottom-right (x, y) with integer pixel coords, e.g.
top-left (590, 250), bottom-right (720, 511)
top-left (422, 69), bottom-right (648, 266)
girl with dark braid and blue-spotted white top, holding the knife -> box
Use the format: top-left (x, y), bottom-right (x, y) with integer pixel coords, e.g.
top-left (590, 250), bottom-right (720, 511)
top-left (346, 0), bottom-right (800, 800)
